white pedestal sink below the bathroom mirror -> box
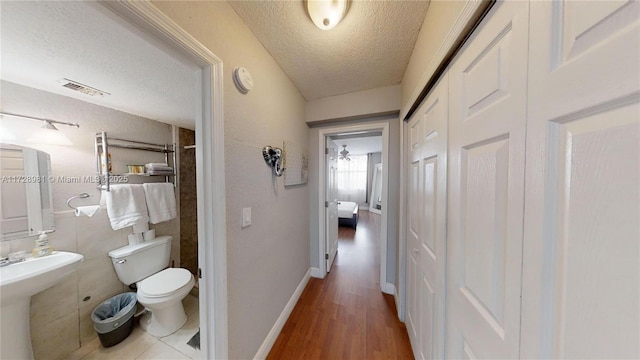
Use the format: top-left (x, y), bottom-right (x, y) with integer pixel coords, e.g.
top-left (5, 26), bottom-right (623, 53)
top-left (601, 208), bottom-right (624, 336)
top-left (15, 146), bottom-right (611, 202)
top-left (0, 251), bottom-right (84, 359)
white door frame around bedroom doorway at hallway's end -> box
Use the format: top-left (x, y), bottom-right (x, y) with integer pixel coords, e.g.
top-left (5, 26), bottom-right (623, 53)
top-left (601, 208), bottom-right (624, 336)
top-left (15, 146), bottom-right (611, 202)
top-left (317, 121), bottom-right (395, 294)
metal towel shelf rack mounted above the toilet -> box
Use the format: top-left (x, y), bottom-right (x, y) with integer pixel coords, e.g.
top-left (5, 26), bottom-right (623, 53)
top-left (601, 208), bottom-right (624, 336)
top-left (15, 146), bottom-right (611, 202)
top-left (95, 131), bottom-right (176, 191)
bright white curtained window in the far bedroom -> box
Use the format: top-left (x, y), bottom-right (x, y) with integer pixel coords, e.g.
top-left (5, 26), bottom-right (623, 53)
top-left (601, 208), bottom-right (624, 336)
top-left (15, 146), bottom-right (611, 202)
top-left (336, 155), bottom-right (368, 204)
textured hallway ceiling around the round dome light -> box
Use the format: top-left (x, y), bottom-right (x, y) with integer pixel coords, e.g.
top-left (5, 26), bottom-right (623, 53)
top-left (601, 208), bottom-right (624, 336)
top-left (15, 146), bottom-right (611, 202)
top-left (230, 0), bottom-right (428, 100)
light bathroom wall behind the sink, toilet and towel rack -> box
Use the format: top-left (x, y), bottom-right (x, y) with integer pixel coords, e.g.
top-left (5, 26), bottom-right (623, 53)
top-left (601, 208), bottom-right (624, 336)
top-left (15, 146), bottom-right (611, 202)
top-left (0, 82), bottom-right (180, 359)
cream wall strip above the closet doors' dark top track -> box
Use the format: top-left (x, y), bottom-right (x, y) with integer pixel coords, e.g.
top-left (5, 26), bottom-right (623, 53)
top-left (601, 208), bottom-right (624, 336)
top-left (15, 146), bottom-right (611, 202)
top-left (400, 0), bottom-right (472, 115)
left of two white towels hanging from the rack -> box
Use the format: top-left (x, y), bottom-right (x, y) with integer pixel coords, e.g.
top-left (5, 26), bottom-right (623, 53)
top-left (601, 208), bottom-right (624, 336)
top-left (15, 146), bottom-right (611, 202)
top-left (103, 185), bottom-right (149, 230)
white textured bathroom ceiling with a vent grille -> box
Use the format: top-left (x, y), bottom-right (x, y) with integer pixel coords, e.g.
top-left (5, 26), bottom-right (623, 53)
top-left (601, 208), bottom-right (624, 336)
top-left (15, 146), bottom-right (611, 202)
top-left (0, 1), bottom-right (196, 129)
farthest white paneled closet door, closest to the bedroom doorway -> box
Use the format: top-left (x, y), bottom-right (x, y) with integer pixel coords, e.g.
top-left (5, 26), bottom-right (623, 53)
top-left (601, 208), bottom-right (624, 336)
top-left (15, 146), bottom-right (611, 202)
top-left (407, 75), bottom-right (449, 359)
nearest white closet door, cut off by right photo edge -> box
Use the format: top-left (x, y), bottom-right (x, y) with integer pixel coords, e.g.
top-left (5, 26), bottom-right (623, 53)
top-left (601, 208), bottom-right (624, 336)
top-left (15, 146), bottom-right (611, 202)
top-left (522, 1), bottom-right (640, 359)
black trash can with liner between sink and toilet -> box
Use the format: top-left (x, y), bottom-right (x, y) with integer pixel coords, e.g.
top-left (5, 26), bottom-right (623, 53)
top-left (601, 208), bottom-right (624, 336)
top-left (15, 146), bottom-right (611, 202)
top-left (91, 292), bottom-right (137, 347)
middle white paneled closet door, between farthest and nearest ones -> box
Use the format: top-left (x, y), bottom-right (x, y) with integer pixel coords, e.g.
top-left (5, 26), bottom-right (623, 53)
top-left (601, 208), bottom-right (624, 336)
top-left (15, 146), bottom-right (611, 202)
top-left (447, 1), bottom-right (529, 359)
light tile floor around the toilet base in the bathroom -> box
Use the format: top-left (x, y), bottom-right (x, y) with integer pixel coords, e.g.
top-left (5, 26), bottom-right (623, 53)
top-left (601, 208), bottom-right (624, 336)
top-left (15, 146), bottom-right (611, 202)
top-left (69, 295), bottom-right (200, 360)
